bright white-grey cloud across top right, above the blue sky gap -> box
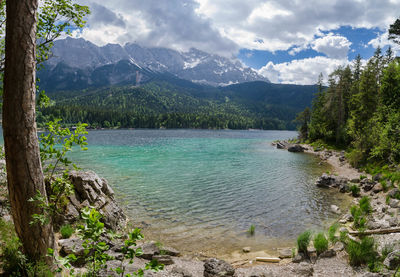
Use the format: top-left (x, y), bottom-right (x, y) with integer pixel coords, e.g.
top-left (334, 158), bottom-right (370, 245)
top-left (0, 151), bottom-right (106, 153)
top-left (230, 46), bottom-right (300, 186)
top-left (197, 0), bottom-right (400, 52)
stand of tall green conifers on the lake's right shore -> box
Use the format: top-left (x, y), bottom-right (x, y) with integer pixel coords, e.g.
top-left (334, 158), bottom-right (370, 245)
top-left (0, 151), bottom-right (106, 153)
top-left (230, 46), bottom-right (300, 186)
top-left (298, 48), bottom-right (400, 166)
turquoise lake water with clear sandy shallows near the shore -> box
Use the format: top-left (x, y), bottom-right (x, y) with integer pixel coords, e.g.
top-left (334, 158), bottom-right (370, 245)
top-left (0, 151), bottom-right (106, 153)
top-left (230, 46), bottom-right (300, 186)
top-left (66, 130), bottom-right (346, 255)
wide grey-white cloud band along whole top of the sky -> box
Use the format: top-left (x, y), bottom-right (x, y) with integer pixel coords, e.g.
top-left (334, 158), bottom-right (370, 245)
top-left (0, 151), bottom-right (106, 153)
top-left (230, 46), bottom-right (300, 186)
top-left (77, 0), bottom-right (400, 57)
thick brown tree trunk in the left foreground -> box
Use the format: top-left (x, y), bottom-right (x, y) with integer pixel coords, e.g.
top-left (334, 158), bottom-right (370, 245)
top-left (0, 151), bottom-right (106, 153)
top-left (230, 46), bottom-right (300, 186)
top-left (3, 0), bottom-right (54, 260)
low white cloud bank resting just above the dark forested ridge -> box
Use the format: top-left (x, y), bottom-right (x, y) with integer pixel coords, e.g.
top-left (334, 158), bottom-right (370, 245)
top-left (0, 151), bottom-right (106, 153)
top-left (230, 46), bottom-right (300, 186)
top-left (258, 56), bottom-right (349, 85)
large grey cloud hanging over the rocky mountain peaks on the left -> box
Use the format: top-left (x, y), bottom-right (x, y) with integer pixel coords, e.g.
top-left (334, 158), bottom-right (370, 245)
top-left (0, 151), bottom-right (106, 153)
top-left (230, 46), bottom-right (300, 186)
top-left (75, 0), bottom-right (239, 55)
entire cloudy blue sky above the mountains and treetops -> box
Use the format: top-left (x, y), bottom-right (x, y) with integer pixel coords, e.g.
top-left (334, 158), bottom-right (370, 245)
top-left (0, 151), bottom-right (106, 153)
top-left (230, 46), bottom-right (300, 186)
top-left (74, 0), bottom-right (400, 84)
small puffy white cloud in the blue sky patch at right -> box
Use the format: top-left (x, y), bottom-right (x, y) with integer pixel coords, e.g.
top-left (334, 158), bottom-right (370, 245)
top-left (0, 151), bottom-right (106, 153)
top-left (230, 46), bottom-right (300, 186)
top-left (311, 33), bottom-right (351, 59)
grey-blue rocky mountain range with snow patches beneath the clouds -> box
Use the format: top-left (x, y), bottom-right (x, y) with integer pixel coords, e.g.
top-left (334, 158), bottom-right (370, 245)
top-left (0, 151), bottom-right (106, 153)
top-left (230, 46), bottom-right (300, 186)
top-left (39, 38), bottom-right (268, 90)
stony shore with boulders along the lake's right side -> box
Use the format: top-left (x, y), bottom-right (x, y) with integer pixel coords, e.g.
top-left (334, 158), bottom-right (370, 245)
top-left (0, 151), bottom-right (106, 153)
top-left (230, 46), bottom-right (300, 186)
top-left (273, 141), bottom-right (400, 276)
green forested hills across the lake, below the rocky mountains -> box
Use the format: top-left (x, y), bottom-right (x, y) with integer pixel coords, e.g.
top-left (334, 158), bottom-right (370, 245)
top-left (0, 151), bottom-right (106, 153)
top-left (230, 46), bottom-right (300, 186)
top-left (38, 74), bottom-right (317, 129)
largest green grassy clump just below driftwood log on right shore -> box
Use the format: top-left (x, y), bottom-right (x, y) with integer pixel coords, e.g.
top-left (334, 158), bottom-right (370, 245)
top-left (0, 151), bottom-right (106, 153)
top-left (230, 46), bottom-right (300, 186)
top-left (346, 237), bottom-right (378, 266)
